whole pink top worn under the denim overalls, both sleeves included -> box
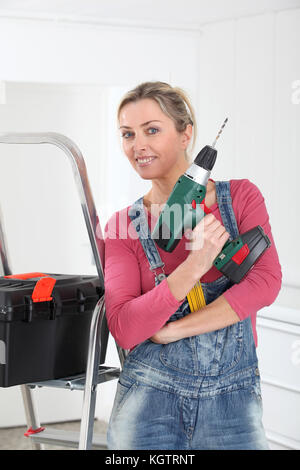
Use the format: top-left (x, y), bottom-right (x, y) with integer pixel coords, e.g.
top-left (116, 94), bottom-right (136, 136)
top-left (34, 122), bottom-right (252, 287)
top-left (104, 179), bottom-right (282, 349)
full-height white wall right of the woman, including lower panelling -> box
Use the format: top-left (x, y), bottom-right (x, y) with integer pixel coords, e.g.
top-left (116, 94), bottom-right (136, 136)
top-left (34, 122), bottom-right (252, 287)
top-left (198, 10), bottom-right (300, 449)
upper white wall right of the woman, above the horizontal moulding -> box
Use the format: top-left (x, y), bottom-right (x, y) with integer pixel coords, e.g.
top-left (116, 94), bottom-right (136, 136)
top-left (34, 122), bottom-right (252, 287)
top-left (199, 10), bottom-right (300, 308)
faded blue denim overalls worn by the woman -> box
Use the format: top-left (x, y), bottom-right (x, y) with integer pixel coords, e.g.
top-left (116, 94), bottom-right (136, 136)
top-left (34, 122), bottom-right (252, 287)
top-left (107, 181), bottom-right (268, 450)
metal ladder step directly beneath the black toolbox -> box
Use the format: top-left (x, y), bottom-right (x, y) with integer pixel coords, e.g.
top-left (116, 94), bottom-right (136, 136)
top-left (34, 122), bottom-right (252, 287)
top-left (26, 366), bottom-right (120, 390)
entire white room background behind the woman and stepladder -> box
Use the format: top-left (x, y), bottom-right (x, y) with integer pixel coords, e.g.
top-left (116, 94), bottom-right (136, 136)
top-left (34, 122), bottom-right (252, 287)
top-left (0, 0), bottom-right (300, 448)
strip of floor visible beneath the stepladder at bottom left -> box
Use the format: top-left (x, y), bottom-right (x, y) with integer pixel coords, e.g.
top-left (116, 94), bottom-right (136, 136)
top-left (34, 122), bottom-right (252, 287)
top-left (0, 421), bottom-right (107, 450)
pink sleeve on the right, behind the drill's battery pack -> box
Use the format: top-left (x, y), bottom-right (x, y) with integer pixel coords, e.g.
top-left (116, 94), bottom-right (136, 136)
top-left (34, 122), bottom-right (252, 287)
top-left (223, 179), bottom-right (282, 320)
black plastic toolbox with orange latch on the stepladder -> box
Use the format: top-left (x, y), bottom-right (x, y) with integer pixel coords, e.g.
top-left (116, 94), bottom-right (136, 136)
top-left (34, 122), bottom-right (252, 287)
top-left (0, 273), bottom-right (108, 387)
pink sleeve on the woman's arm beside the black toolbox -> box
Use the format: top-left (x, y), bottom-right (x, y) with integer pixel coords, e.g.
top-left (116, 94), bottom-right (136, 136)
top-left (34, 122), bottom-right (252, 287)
top-left (104, 213), bottom-right (182, 349)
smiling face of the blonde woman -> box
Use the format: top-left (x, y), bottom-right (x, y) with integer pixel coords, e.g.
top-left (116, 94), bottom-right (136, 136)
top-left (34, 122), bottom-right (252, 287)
top-left (119, 99), bottom-right (192, 179)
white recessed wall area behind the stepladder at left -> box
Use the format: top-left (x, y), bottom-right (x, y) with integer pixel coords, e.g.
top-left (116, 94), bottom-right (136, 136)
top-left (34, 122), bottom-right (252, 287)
top-left (0, 82), bottom-right (105, 426)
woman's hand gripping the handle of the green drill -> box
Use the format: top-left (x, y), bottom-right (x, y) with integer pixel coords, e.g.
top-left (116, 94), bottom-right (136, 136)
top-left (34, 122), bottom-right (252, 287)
top-left (185, 214), bottom-right (229, 278)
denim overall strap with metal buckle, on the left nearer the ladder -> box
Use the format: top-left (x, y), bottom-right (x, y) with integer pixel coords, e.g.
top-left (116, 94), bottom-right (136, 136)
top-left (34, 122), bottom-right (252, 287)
top-left (128, 196), bottom-right (166, 284)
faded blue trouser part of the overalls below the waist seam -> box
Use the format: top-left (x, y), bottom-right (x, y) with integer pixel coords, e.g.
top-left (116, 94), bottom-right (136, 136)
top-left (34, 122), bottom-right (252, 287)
top-left (107, 358), bottom-right (268, 450)
